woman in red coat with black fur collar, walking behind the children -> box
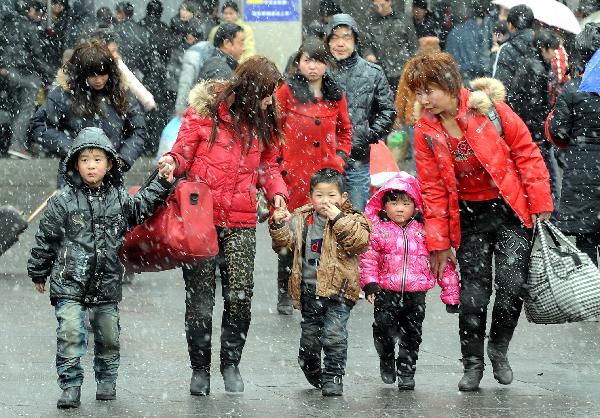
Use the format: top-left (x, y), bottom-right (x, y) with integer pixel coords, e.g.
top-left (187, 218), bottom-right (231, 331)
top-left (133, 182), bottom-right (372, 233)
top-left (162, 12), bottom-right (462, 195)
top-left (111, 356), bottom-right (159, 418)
top-left (277, 41), bottom-right (352, 315)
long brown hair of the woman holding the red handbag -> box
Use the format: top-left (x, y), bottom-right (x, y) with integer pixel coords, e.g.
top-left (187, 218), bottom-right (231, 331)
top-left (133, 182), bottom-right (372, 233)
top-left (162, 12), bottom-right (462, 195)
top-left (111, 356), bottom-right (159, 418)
top-left (208, 55), bottom-right (282, 152)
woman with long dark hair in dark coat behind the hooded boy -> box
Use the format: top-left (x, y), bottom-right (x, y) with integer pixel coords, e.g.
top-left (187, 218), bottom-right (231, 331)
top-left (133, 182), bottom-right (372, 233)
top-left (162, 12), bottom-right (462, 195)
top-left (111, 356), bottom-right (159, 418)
top-left (30, 40), bottom-right (146, 181)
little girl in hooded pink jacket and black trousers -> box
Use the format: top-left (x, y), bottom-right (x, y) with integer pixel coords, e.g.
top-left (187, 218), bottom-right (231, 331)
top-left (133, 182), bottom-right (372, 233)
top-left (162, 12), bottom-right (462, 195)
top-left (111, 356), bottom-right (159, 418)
top-left (360, 172), bottom-right (460, 390)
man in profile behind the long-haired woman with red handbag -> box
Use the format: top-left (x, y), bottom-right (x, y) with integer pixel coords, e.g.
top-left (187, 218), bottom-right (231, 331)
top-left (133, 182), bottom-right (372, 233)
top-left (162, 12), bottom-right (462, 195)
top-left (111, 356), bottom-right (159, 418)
top-left (198, 23), bottom-right (244, 80)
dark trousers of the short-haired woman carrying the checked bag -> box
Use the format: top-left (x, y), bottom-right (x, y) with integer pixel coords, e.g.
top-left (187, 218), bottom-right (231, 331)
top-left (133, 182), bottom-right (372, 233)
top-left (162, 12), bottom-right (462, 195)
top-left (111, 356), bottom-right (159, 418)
top-left (457, 199), bottom-right (532, 358)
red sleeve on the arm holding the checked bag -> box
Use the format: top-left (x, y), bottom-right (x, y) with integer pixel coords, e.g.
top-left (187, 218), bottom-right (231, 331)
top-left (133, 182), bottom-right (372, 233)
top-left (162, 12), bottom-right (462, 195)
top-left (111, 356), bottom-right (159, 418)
top-left (496, 102), bottom-right (554, 214)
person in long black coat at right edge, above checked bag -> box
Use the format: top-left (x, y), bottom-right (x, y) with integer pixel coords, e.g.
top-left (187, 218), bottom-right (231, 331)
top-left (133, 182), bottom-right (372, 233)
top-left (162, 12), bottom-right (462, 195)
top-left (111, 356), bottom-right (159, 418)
top-left (547, 23), bottom-right (600, 263)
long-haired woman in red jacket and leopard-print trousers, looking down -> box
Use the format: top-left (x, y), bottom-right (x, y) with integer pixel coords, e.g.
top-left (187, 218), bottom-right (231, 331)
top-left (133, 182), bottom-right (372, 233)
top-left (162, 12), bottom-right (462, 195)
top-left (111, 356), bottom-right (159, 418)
top-left (159, 56), bottom-right (287, 395)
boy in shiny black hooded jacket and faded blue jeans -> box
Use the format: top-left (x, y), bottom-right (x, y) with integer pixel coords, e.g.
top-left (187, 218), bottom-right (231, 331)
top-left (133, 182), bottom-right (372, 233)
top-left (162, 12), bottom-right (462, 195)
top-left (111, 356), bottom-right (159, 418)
top-left (27, 128), bottom-right (174, 408)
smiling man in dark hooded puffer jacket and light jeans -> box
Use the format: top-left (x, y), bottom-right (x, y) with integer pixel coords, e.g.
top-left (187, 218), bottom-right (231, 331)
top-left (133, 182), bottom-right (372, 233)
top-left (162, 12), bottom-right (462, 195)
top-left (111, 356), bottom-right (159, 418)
top-left (327, 14), bottom-right (396, 211)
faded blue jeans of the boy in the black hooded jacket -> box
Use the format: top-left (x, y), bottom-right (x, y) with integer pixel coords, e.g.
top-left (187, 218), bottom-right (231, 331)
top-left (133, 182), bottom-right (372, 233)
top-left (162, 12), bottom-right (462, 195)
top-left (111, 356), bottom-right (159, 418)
top-left (54, 299), bottom-right (121, 390)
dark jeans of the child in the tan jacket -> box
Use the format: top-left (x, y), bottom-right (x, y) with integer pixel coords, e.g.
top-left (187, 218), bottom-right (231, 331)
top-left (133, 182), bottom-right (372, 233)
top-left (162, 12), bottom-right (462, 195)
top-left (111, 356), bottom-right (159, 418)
top-left (298, 286), bottom-right (352, 376)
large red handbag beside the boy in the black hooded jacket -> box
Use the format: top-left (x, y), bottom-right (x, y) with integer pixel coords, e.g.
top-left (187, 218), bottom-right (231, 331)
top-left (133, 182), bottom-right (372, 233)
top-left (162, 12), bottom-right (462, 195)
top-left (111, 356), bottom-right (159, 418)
top-left (120, 175), bottom-right (219, 273)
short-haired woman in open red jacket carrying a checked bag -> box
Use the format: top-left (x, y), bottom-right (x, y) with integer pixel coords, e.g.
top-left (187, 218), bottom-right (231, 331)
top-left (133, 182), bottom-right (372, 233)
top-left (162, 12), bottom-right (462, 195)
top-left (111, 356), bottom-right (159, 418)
top-left (403, 53), bottom-right (553, 391)
